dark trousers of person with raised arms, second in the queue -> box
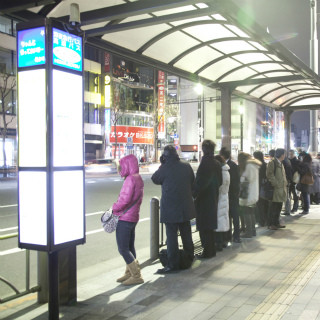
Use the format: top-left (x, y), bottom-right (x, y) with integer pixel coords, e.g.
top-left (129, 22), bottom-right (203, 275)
top-left (165, 221), bottom-right (194, 270)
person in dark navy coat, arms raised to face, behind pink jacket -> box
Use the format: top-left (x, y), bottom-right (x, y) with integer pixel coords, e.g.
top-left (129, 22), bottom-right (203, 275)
top-left (151, 145), bottom-right (195, 274)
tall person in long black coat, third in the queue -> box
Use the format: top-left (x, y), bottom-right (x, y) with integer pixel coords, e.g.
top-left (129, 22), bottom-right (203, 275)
top-left (193, 140), bottom-right (222, 258)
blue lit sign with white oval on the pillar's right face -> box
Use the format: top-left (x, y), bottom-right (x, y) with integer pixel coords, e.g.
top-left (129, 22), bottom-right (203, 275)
top-left (52, 28), bottom-right (82, 71)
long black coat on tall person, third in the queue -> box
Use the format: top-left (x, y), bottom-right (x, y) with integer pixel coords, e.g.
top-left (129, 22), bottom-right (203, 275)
top-left (193, 155), bottom-right (222, 230)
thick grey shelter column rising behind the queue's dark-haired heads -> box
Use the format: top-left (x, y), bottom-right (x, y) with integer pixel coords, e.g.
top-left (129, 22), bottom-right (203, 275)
top-left (220, 86), bottom-right (232, 151)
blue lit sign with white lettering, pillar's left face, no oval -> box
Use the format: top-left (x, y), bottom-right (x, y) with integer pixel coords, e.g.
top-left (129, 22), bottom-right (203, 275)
top-left (17, 27), bottom-right (46, 68)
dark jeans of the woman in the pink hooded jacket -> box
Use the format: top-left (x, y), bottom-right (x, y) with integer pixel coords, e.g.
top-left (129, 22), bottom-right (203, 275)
top-left (116, 220), bottom-right (137, 264)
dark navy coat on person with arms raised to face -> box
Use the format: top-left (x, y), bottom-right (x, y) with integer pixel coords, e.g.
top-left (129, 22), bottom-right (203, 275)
top-left (151, 157), bottom-right (196, 223)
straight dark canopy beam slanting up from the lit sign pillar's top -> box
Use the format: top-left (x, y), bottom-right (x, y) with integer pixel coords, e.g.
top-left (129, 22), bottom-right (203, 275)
top-left (86, 6), bottom-right (216, 37)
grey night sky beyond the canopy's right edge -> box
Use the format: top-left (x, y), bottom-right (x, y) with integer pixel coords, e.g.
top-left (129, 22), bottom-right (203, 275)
top-left (233, 0), bottom-right (312, 144)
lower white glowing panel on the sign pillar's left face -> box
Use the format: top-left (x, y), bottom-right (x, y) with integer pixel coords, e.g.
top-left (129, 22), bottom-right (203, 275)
top-left (19, 171), bottom-right (47, 246)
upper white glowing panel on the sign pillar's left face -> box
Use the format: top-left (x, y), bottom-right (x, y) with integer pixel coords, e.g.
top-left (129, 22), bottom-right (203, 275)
top-left (18, 69), bottom-right (47, 167)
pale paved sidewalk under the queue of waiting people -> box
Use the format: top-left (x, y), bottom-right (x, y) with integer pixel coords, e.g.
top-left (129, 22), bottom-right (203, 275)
top-left (0, 206), bottom-right (320, 320)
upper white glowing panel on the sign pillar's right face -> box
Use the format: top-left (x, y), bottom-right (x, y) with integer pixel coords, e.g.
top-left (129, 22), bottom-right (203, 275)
top-left (52, 70), bottom-right (83, 166)
